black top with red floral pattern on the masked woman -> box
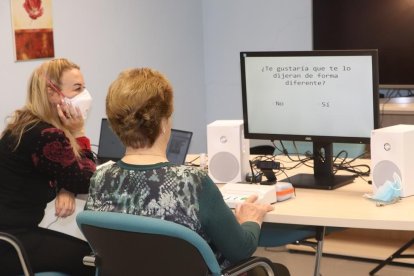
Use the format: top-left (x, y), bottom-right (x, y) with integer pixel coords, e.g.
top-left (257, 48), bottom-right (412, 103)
top-left (0, 122), bottom-right (96, 229)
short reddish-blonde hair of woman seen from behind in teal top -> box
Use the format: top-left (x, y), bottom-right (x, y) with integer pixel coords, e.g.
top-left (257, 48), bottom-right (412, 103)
top-left (106, 68), bottom-right (173, 148)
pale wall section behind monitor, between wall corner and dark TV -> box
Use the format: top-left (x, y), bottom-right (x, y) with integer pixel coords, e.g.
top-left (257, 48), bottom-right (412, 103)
top-left (203, 0), bottom-right (312, 123)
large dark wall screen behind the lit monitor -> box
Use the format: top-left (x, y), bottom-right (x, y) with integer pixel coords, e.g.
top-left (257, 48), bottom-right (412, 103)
top-left (312, 0), bottom-right (414, 88)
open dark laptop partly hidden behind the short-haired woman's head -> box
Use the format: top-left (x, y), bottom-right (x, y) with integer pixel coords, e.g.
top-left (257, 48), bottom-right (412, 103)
top-left (97, 118), bottom-right (193, 165)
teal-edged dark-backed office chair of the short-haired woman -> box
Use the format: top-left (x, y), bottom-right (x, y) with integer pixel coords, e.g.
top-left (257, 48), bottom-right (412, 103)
top-left (76, 211), bottom-right (280, 276)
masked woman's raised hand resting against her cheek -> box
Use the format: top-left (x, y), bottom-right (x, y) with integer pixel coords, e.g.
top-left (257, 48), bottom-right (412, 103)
top-left (57, 103), bottom-right (85, 137)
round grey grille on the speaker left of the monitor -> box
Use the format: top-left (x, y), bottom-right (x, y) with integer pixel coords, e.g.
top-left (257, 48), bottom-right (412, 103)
top-left (208, 151), bottom-right (240, 183)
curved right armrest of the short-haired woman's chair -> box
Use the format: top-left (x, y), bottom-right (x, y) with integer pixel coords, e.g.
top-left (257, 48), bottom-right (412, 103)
top-left (222, 257), bottom-right (277, 276)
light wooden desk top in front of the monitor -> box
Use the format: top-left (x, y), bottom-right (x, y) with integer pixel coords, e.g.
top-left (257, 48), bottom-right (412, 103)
top-left (265, 178), bottom-right (414, 230)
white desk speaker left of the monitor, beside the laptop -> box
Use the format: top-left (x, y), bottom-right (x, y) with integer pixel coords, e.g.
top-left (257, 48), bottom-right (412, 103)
top-left (207, 120), bottom-right (250, 183)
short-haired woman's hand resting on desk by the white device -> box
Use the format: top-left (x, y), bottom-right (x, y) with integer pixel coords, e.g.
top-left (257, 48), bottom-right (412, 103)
top-left (235, 195), bottom-right (274, 225)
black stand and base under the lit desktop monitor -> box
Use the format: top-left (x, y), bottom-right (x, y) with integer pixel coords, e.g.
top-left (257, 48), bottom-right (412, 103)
top-left (281, 142), bottom-right (355, 190)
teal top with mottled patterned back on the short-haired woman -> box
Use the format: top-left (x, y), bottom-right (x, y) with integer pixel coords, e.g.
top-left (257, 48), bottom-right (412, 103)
top-left (85, 161), bottom-right (260, 266)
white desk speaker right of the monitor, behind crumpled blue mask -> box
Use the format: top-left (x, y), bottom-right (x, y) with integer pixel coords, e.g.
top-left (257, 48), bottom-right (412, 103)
top-left (371, 125), bottom-right (414, 197)
